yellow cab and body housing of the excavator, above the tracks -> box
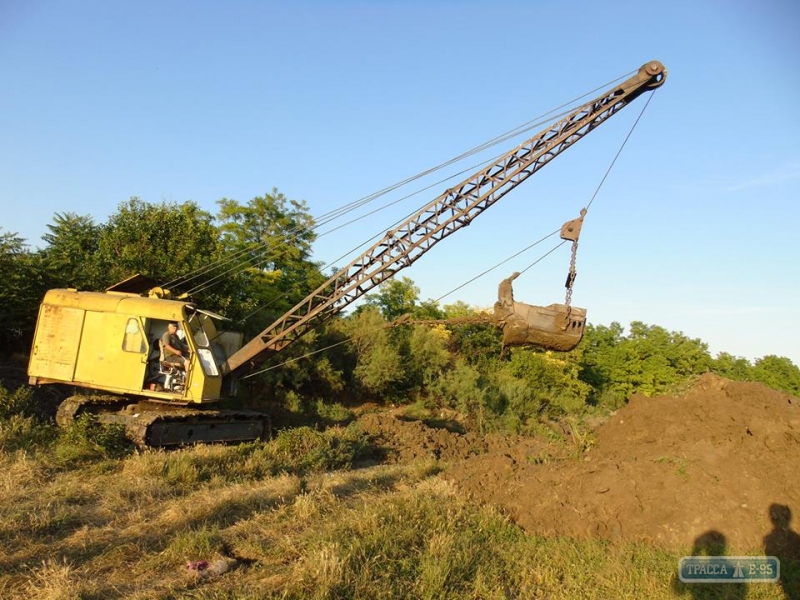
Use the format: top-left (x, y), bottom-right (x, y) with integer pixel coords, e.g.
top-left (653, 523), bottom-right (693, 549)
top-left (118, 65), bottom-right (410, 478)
top-left (28, 289), bottom-right (242, 404)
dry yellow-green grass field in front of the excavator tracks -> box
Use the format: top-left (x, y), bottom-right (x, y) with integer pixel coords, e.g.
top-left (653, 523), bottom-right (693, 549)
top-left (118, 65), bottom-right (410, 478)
top-left (0, 426), bottom-right (800, 600)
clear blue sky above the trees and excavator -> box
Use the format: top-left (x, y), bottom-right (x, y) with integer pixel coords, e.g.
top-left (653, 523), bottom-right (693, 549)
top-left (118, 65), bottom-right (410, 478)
top-left (0, 0), bottom-right (800, 365)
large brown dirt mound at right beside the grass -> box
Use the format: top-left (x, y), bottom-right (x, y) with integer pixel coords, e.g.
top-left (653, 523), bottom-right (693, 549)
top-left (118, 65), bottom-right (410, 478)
top-left (446, 375), bottom-right (800, 549)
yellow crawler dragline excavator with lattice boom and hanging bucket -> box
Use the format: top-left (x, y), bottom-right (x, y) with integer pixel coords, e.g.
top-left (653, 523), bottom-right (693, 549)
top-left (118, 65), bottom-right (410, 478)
top-left (28, 61), bottom-right (667, 446)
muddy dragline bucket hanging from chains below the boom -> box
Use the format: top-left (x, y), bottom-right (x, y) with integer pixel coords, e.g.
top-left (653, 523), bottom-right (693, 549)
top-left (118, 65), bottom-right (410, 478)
top-left (502, 302), bottom-right (586, 352)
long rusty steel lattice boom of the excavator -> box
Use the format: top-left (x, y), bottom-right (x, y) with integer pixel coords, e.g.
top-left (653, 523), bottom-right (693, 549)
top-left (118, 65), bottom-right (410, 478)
top-left (226, 61), bottom-right (666, 373)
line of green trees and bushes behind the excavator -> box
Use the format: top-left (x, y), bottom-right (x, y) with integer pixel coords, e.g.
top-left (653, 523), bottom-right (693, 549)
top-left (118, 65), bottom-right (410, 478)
top-left (0, 190), bottom-right (800, 431)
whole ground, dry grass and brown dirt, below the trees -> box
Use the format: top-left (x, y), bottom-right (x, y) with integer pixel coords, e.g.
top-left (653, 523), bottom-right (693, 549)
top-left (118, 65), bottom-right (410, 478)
top-left (6, 375), bottom-right (800, 600)
